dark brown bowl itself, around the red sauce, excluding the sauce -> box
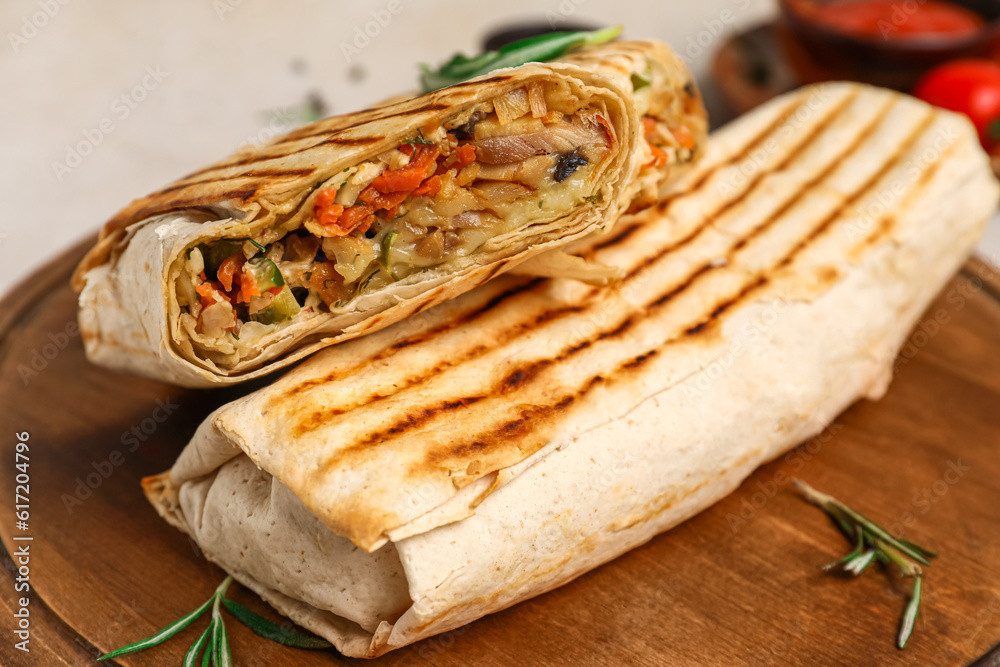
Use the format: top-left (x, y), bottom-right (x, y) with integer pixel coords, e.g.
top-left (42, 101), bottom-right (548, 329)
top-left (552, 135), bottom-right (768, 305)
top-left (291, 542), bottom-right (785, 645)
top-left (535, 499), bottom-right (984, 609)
top-left (779, 0), bottom-right (1000, 90)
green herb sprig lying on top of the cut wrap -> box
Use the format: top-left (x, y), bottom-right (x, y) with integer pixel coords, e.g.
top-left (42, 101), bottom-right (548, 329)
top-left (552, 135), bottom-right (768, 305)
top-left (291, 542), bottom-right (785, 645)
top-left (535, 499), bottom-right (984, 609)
top-left (420, 26), bottom-right (622, 93)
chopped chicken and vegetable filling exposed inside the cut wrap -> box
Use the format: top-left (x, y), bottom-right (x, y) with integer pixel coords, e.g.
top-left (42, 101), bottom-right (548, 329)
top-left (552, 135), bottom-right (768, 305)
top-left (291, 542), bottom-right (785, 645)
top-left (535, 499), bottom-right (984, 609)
top-left (177, 83), bottom-right (617, 354)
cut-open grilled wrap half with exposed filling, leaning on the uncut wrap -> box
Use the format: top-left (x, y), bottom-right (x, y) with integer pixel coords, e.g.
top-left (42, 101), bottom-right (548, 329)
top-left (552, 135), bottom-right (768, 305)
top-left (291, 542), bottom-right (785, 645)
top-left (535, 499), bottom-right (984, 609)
top-left (74, 42), bottom-right (707, 386)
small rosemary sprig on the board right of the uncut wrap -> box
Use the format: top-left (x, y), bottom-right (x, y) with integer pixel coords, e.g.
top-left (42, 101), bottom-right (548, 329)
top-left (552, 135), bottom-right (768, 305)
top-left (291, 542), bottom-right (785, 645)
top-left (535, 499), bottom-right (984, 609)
top-left (794, 479), bottom-right (937, 649)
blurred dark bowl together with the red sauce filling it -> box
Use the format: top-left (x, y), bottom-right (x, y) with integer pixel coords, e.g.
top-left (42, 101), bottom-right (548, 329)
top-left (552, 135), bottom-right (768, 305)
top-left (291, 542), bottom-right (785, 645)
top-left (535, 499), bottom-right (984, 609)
top-left (779, 0), bottom-right (1000, 90)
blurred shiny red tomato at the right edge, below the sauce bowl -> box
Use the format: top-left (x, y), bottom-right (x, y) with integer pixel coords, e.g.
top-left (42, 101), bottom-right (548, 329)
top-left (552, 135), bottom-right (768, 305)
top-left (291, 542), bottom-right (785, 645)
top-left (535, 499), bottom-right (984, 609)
top-left (913, 59), bottom-right (1000, 152)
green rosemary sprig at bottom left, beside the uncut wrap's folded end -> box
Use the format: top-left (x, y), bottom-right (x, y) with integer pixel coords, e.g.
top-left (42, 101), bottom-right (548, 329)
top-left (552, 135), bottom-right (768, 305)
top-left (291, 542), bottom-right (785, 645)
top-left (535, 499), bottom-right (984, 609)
top-left (98, 576), bottom-right (332, 667)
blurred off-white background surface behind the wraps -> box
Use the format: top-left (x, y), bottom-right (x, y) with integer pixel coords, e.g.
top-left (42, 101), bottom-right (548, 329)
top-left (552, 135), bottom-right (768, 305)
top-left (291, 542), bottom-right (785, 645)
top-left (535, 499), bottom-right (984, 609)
top-left (0, 0), bottom-right (1000, 293)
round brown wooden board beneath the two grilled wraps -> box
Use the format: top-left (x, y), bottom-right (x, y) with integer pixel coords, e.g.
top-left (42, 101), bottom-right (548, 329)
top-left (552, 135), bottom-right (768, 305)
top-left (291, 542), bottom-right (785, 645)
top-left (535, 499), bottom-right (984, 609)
top-left (0, 241), bottom-right (1000, 666)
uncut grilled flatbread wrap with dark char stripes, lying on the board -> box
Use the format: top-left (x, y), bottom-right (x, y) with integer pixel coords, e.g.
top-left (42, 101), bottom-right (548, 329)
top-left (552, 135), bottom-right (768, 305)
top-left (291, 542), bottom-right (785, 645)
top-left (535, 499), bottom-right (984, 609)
top-left (144, 84), bottom-right (998, 657)
